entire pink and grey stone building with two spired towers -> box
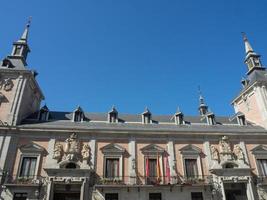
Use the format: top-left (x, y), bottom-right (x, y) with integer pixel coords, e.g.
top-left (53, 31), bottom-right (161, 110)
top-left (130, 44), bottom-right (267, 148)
top-left (0, 21), bottom-right (267, 200)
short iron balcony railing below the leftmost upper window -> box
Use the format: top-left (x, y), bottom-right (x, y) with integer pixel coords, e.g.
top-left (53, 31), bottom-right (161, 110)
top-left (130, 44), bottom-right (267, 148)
top-left (4, 175), bottom-right (44, 185)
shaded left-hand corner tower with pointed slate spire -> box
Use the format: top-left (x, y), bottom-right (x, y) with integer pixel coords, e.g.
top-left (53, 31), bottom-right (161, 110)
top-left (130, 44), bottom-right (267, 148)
top-left (0, 21), bottom-right (44, 125)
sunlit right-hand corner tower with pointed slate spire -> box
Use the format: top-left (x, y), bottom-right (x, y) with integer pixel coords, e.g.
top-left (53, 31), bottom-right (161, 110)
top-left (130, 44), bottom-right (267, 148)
top-left (232, 33), bottom-right (267, 128)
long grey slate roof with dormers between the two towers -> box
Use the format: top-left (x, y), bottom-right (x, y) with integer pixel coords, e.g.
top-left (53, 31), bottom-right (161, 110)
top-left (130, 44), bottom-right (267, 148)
top-left (19, 112), bottom-right (267, 133)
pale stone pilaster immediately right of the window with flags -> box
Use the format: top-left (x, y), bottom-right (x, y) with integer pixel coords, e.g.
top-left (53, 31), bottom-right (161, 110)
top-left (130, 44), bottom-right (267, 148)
top-left (167, 139), bottom-right (177, 184)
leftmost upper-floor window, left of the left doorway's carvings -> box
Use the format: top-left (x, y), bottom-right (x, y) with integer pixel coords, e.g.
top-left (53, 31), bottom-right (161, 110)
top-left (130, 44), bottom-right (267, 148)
top-left (19, 157), bottom-right (37, 178)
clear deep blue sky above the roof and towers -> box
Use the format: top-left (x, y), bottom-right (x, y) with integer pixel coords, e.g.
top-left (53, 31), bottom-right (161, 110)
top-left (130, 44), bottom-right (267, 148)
top-left (0, 0), bottom-right (267, 115)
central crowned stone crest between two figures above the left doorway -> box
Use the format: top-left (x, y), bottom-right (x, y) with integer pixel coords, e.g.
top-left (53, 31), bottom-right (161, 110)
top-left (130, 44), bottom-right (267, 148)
top-left (63, 133), bottom-right (80, 161)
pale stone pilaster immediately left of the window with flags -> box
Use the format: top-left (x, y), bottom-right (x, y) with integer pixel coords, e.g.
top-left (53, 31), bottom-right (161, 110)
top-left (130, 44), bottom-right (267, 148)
top-left (128, 138), bottom-right (137, 184)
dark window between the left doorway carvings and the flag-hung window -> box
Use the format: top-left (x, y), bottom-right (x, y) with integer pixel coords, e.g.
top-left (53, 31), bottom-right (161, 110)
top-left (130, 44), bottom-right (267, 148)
top-left (105, 158), bottom-right (120, 178)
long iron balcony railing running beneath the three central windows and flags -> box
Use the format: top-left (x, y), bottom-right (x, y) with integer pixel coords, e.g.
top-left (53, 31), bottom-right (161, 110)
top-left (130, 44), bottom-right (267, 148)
top-left (96, 175), bottom-right (212, 185)
